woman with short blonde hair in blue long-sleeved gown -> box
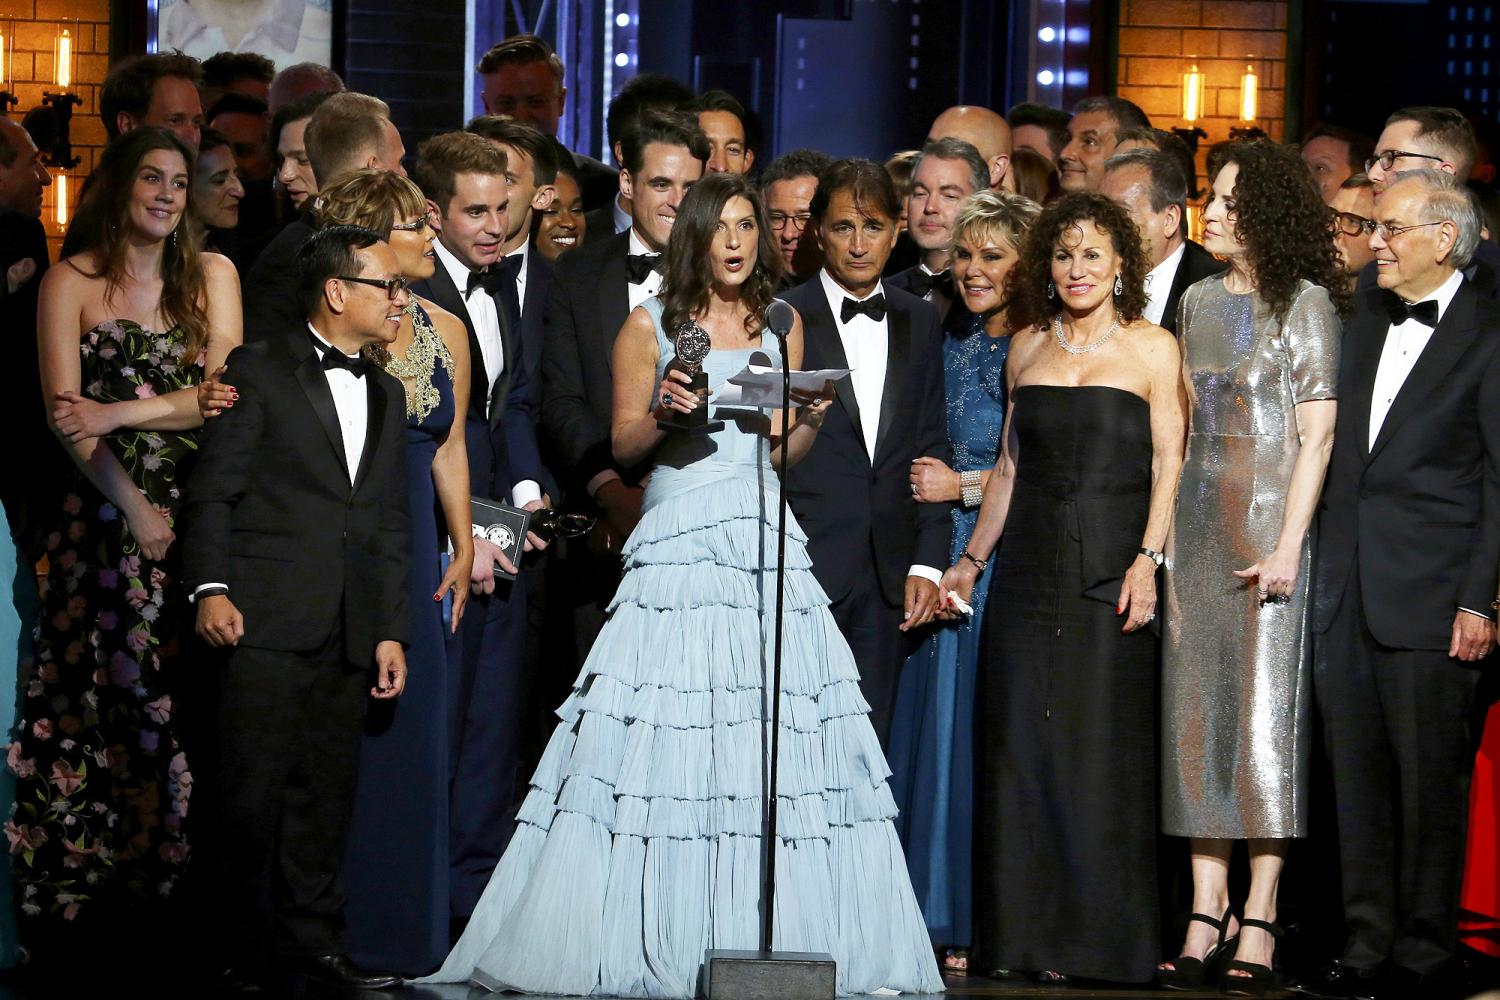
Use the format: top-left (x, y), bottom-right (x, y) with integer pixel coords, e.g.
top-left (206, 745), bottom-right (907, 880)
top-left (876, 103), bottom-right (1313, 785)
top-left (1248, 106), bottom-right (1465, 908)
top-left (891, 192), bottom-right (1041, 973)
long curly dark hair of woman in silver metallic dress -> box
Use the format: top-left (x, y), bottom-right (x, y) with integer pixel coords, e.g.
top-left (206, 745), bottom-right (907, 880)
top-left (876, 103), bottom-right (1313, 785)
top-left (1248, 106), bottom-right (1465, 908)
top-left (1209, 139), bottom-right (1349, 322)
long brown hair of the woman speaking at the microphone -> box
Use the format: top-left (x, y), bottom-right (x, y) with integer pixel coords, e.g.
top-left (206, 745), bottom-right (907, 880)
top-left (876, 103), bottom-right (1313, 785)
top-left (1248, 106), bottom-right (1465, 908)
top-left (660, 174), bottom-right (782, 336)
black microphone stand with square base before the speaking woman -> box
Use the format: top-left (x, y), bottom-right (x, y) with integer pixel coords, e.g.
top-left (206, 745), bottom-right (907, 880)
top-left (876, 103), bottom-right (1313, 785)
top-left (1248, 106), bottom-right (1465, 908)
top-left (704, 300), bottom-right (837, 1000)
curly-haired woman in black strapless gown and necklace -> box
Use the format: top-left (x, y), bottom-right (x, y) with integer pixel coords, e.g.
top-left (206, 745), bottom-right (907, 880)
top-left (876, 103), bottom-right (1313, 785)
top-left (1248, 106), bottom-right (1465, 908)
top-left (944, 195), bottom-right (1185, 982)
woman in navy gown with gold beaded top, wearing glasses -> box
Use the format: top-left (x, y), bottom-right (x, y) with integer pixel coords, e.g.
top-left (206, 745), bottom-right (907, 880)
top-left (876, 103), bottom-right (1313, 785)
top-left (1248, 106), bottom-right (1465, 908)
top-left (318, 169), bottom-right (474, 976)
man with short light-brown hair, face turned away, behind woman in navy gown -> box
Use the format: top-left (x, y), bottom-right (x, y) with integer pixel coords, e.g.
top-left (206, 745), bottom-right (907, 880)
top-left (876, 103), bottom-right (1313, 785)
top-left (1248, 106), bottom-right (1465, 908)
top-left (243, 91), bottom-right (407, 343)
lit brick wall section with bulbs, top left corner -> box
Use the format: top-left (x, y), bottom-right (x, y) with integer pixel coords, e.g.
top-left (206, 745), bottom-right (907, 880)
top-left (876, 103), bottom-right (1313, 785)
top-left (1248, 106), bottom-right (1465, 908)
top-left (0, 0), bottom-right (110, 261)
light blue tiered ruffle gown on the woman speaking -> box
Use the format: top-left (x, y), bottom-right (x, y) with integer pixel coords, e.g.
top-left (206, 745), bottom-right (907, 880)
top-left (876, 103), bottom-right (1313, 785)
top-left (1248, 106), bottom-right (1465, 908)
top-left (431, 298), bottom-right (942, 997)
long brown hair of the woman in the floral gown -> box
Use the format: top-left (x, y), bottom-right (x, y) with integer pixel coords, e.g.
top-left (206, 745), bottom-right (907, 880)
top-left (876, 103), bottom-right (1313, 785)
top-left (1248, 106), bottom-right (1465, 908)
top-left (69, 126), bottom-right (209, 361)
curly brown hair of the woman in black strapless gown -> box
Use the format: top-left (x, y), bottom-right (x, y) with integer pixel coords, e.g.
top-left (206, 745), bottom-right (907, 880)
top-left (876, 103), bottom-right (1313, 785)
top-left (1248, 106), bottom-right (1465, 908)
top-left (1010, 192), bottom-right (1151, 330)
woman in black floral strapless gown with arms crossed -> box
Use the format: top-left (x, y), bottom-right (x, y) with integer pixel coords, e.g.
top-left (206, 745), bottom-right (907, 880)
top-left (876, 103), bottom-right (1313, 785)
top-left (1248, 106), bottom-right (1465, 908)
top-left (5, 129), bottom-right (240, 946)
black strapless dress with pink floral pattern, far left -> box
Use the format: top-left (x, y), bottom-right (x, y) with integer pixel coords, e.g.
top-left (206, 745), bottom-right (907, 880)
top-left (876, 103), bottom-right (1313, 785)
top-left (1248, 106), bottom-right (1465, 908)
top-left (5, 319), bottom-right (203, 921)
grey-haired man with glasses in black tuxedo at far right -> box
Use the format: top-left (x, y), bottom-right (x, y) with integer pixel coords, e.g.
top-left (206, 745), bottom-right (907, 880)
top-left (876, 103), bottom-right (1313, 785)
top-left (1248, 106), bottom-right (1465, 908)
top-left (1310, 169), bottom-right (1500, 997)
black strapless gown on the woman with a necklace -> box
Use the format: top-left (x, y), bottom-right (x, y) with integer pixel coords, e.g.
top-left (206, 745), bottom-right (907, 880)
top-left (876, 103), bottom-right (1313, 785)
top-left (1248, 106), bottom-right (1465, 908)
top-left (974, 385), bottom-right (1158, 982)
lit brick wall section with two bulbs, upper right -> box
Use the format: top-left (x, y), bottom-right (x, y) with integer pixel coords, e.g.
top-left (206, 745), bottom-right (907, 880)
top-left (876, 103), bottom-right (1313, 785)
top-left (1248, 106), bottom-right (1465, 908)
top-left (1118, 0), bottom-right (1287, 200)
